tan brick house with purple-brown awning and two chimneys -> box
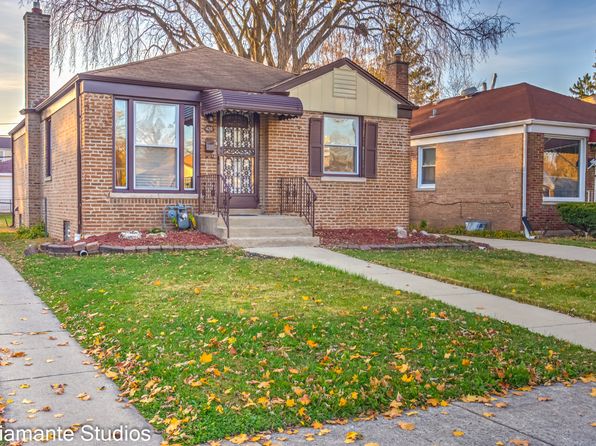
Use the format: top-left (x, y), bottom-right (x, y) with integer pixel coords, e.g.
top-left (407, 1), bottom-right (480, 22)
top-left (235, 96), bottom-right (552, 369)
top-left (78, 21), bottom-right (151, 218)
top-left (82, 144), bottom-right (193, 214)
top-left (11, 4), bottom-right (415, 244)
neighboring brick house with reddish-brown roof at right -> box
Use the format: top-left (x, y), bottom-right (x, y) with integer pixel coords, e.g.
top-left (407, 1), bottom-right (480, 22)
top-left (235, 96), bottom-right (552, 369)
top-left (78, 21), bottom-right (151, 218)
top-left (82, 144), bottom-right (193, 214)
top-left (410, 83), bottom-right (596, 231)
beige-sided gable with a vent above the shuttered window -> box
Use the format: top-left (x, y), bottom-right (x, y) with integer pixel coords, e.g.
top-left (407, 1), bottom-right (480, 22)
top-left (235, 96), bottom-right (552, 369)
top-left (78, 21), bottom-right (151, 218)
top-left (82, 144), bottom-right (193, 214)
top-left (288, 65), bottom-right (398, 118)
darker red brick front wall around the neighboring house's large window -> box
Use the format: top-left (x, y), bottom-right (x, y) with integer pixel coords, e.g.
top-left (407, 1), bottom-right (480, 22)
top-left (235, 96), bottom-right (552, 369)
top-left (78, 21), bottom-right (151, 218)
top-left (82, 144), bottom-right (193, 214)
top-left (527, 133), bottom-right (596, 230)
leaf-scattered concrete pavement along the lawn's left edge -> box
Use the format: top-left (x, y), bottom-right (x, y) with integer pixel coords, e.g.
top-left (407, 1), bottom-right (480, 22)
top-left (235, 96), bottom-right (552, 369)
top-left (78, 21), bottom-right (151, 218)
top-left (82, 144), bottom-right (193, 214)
top-left (0, 257), bottom-right (162, 445)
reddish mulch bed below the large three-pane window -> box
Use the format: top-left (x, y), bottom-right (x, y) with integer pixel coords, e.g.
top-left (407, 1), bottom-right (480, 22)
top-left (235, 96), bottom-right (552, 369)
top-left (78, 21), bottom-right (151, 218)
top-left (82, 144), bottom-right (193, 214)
top-left (84, 230), bottom-right (223, 247)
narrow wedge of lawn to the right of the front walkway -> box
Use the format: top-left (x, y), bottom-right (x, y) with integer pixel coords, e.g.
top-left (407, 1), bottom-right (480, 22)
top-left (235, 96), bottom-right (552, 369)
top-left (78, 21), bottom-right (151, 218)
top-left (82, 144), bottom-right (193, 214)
top-left (346, 249), bottom-right (596, 320)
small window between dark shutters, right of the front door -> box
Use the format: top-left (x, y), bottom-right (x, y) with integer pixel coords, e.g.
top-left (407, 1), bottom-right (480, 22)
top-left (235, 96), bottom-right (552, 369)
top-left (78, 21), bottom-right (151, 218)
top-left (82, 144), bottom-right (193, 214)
top-left (323, 116), bottom-right (360, 175)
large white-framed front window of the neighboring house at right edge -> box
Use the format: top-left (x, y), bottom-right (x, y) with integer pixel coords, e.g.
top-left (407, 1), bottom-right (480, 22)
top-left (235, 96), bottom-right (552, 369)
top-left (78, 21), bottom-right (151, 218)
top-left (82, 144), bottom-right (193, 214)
top-left (542, 136), bottom-right (585, 201)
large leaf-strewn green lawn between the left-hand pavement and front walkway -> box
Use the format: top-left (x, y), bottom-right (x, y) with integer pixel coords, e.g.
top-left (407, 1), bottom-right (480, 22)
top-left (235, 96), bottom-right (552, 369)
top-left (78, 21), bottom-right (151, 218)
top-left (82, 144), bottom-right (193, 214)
top-left (0, 235), bottom-right (596, 445)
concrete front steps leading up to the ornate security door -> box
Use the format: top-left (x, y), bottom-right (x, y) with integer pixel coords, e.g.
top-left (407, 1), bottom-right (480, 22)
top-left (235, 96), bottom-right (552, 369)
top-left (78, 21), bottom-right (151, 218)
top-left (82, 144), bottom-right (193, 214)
top-left (198, 209), bottom-right (319, 248)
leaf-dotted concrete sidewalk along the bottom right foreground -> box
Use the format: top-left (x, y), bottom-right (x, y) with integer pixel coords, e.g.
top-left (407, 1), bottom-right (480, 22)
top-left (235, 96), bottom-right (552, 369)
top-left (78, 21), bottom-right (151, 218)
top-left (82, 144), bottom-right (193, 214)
top-left (212, 383), bottom-right (596, 446)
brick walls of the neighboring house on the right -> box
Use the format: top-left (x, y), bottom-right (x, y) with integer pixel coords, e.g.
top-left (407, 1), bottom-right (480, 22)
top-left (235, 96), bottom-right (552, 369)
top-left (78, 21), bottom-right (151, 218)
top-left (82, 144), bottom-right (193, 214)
top-left (410, 133), bottom-right (596, 231)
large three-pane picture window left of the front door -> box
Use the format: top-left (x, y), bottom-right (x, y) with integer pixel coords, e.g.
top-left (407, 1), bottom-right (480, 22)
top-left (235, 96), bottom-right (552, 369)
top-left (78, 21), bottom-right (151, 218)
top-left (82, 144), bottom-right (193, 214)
top-left (114, 99), bottom-right (196, 192)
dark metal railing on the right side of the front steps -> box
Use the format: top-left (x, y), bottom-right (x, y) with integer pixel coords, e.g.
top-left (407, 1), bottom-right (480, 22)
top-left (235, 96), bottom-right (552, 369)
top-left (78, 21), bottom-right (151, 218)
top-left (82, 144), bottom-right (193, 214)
top-left (279, 177), bottom-right (317, 236)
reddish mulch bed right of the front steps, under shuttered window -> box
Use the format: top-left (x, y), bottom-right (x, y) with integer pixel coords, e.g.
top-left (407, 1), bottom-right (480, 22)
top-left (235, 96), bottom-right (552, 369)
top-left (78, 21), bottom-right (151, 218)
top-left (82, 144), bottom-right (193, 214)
top-left (317, 229), bottom-right (469, 249)
